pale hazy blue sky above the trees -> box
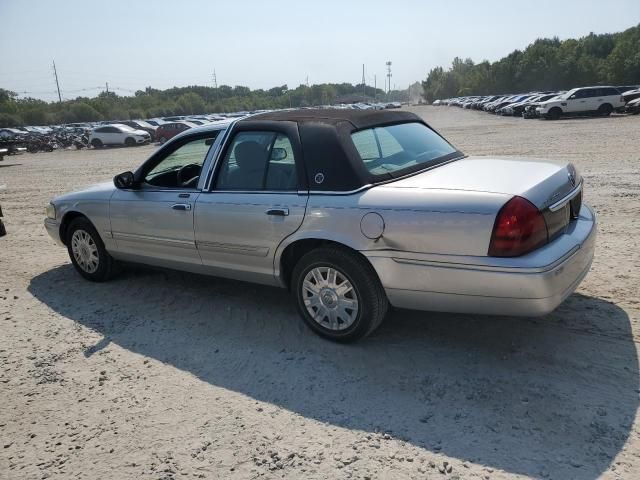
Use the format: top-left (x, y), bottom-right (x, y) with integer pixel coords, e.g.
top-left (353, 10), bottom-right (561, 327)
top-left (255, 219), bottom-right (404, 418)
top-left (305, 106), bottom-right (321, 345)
top-left (0, 0), bottom-right (640, 100)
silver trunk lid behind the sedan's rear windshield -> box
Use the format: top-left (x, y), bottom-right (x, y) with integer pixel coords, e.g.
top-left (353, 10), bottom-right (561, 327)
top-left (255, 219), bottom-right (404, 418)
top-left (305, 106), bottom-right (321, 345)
top-left (387, 157), bottom-right (580, 209)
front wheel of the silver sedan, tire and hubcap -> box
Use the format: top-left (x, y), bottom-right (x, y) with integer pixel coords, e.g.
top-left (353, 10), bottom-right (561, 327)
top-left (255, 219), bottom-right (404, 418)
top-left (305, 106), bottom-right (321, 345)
top-left (67, 217), bottom-right (114, 282)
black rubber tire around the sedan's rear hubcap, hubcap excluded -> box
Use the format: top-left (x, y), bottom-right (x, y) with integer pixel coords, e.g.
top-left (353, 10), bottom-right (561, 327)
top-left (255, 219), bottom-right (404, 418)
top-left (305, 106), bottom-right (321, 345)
top-left (291, 247), bottom-right (389, 343)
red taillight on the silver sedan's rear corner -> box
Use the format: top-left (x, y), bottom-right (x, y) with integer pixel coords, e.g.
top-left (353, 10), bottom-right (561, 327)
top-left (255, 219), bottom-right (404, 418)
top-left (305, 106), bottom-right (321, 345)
top-left (489, 197), bottom-right (548, 257)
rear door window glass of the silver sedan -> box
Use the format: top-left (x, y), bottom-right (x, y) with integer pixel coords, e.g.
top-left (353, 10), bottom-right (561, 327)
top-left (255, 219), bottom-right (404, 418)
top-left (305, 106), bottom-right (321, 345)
top-left (215, 131), bottom-right (298, 191)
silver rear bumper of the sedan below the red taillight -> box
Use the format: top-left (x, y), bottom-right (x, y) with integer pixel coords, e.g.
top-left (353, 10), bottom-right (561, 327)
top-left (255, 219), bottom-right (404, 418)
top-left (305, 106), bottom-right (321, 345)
top-left (364, 205), bottom-right (596, 316)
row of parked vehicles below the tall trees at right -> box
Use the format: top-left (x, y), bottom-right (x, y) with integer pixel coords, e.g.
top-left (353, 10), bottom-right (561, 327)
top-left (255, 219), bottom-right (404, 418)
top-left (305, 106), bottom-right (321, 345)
top-left (433, 85), bottom-right (640, 120)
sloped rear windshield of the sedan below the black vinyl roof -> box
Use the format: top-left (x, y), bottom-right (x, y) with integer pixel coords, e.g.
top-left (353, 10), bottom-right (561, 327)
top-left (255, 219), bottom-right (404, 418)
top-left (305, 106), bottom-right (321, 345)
top-left (351, 122), bottom-right (458, 175)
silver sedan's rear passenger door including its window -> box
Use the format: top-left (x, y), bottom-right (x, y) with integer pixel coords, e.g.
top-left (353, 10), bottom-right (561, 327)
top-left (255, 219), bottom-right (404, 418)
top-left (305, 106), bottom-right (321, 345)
top-left (195, 122), bottom-right (308, 284)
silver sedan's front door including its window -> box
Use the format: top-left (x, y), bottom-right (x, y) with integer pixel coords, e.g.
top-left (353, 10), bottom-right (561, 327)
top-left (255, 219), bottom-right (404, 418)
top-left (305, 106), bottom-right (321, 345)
top-left (110, 131), bottom-right (218, 266)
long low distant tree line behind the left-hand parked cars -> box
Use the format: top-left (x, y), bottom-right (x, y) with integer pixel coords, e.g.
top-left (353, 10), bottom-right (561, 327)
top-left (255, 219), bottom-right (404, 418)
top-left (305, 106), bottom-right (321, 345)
top-left (0, 83), bottom-right (410, 127)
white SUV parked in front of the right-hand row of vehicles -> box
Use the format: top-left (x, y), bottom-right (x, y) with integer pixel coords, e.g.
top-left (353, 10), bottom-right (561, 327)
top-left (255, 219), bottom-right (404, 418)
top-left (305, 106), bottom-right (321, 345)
top-left (536, 87), bottom-right (625, 120)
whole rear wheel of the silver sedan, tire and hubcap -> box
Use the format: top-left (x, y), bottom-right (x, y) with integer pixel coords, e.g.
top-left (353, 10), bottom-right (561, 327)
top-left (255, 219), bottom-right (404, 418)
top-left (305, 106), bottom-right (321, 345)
top-left (292, 247), bottom-right (389, 343)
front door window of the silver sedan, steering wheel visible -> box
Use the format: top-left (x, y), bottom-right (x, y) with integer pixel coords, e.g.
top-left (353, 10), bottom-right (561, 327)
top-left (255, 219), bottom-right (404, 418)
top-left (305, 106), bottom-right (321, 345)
top-left (144, 132), bottom-right (218, 189)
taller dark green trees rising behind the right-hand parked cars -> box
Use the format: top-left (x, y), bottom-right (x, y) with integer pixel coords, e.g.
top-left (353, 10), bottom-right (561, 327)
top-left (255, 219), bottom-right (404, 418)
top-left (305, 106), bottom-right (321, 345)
top-left (422, 24), bottom-right (640, 102)
